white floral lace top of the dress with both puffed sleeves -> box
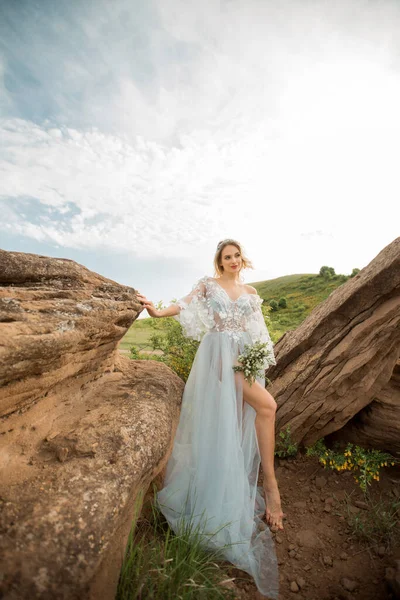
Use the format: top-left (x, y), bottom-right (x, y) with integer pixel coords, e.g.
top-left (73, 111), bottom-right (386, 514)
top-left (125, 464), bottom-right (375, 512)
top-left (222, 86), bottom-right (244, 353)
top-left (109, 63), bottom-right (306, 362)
top-left (173, 276), bottom-right (276, 368)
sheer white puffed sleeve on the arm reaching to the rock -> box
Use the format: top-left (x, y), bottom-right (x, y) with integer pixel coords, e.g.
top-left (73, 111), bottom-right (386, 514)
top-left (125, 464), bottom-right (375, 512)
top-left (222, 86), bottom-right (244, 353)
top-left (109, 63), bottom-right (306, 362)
top-left (171, 276), bottom-right (214, 341)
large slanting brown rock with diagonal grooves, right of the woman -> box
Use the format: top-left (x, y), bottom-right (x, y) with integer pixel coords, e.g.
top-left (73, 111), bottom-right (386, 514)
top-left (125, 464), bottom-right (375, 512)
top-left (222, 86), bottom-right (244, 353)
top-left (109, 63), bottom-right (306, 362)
top-left (267, 238), bottom-right (400, 451)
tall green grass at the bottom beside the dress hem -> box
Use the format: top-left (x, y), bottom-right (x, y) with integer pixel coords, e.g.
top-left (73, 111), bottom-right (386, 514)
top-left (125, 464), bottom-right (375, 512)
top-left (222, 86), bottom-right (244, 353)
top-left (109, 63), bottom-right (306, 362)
top-left (116, 492), bottom-right (239, 600)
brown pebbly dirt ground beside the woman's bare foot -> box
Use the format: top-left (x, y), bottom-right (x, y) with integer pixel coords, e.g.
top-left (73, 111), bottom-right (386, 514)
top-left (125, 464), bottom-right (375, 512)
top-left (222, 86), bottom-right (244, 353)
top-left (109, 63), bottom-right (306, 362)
top-left (222, 453), bottom-right (400, 600)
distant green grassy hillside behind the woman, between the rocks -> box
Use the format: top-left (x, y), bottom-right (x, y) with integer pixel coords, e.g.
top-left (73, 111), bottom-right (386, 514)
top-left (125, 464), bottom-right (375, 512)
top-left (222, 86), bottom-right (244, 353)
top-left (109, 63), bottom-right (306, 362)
top-left (119, 273), bottom-right (346, 350)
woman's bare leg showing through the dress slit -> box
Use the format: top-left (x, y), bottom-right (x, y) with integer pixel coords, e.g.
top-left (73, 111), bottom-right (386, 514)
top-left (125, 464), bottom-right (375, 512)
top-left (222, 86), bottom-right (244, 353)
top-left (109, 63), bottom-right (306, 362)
top-left (235, 371), bottom-right (285, 529)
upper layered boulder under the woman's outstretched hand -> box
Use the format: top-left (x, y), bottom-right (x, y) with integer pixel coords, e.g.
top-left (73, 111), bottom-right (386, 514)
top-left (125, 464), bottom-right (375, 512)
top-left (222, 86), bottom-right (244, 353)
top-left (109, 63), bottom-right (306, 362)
top-left (0, 250), bottom-right (141, 416)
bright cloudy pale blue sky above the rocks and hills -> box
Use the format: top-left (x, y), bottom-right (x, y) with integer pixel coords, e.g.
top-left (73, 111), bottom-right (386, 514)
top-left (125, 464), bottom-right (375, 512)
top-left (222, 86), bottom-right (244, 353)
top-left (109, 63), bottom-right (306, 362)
top-left (0, 0), bottom-right (400, 316)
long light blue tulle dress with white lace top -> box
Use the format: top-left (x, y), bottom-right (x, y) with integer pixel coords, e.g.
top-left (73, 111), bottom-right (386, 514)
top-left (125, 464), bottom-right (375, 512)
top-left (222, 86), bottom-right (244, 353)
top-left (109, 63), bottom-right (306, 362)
top-left (157, 276), bottom-right (279, 598)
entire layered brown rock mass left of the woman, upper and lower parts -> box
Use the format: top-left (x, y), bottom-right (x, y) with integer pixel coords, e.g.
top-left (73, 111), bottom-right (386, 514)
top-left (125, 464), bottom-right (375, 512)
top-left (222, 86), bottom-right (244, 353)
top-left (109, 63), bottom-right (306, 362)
top-left (0, 251), bottom-right (184, 600)
